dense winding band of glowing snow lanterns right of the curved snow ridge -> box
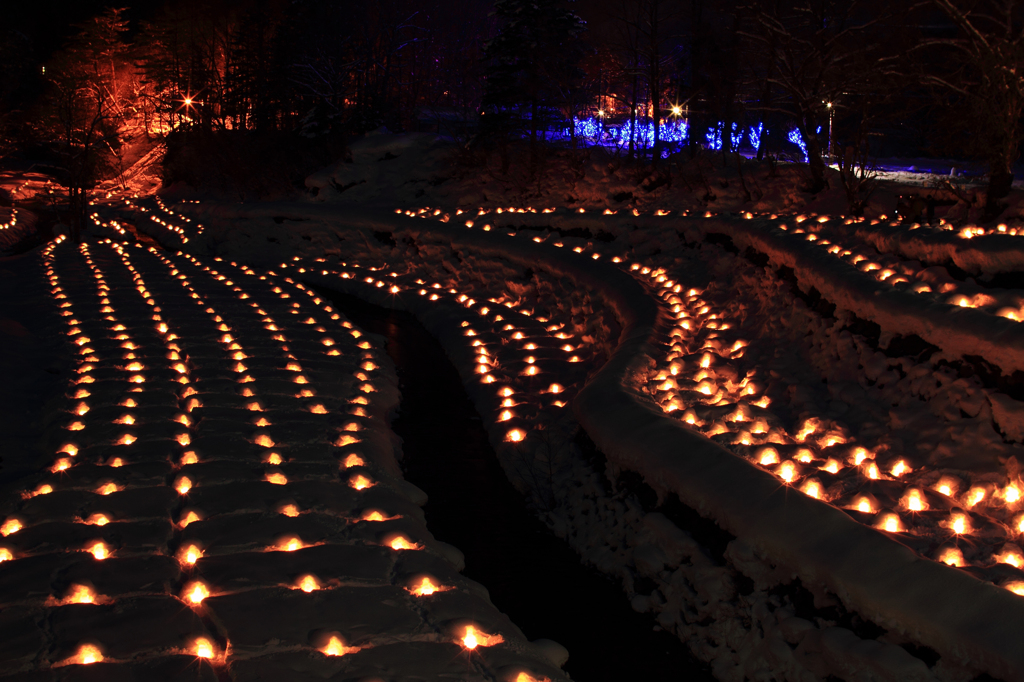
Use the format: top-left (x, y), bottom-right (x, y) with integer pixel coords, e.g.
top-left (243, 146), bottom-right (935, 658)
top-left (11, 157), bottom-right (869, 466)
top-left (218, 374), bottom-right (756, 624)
top-left (630, 258), bottom-right (1024, 594)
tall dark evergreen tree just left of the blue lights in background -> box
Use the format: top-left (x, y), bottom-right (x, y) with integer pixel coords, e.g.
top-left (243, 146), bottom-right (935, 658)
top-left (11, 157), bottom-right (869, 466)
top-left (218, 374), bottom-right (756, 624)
top-left (481, 0), bottom-right (586, 174)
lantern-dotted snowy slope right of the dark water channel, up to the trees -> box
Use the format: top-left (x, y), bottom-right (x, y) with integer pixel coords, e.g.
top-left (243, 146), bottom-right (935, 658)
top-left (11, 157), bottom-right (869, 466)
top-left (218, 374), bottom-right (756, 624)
top-left (9, 130), bottom-right (1024, 681)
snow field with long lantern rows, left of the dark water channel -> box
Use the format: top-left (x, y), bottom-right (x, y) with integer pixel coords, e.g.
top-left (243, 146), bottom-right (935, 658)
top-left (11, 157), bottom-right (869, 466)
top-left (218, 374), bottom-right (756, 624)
top-left (0, 236), bottom-right (565, 682)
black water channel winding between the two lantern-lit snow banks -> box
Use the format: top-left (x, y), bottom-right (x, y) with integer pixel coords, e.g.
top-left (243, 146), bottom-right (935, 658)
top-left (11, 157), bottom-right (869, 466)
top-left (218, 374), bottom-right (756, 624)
top-left (319, 290), bottom-right (714, 682)
